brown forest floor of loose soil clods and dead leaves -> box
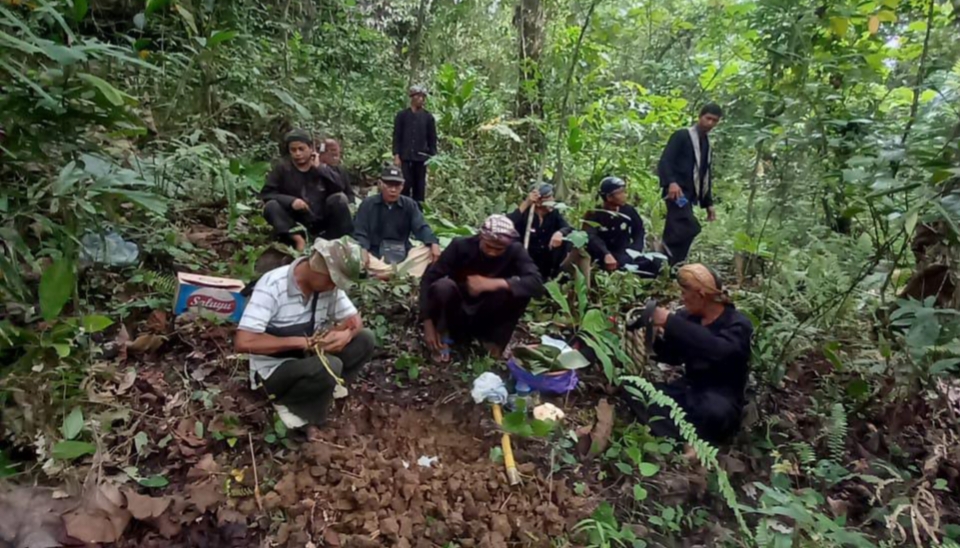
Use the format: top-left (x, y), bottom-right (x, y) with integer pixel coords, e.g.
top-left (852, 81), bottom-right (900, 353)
top-left (0, 211), bottom-right (960, 548)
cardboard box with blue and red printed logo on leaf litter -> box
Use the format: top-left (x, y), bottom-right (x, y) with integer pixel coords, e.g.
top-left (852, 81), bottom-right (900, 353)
top-left (173, 272), bottom-right (247, 322)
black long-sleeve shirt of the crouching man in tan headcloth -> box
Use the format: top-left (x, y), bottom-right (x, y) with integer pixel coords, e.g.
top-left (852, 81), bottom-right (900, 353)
top-left (653, 304), bottom-right (753, 401)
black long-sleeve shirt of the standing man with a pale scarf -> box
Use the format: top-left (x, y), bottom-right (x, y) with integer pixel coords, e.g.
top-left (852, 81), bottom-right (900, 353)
top-left (657, 128), bottom-right (713, 208)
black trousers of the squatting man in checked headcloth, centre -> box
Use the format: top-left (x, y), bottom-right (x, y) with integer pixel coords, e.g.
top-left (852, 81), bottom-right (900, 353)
top-left (426, 278), bottom-right (530, 350)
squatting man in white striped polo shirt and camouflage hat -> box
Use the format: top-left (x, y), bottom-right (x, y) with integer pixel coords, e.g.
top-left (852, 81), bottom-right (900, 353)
top-left (234, 239), bottom-right (375, 437)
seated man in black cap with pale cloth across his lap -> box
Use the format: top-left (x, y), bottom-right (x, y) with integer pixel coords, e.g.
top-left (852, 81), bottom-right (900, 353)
top-left (354, 166), bottom-right (440, 277)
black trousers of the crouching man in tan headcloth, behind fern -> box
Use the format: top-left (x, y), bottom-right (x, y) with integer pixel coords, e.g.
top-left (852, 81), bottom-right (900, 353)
top-left (625, 379), bottom-right (743, 444)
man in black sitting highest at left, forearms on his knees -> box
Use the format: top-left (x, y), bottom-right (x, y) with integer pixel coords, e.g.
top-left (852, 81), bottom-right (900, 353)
top-left (260, 129), bottom-right (353, 251)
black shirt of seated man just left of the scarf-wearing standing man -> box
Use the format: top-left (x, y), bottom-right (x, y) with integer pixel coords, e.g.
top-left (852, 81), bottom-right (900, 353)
top-left (583, 205), bottom-right (646, 265)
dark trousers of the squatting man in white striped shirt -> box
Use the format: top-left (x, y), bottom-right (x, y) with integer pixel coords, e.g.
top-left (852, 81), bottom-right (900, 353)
top-left (263, 329), bottom-right (376, 426)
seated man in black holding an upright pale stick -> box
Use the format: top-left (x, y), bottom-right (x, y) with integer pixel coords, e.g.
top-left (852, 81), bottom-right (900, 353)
top-left (508, 183), bottom-right (573, 280)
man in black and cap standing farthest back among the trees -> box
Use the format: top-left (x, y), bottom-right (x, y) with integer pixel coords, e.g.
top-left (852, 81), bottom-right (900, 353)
top-left (393, 86), bottom-right (437, 204)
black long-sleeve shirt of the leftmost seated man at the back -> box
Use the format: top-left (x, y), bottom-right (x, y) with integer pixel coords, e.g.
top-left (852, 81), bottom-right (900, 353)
top-left (260, 158), bottom-right (340, 217)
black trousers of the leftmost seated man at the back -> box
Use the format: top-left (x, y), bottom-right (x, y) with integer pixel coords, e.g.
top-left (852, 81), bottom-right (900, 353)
top-left (263, 192), bottom-right (353, 243)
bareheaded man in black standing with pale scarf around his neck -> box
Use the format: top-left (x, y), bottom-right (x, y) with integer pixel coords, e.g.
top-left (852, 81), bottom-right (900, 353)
top-left (657, 103), bottom-right (723, 266)
